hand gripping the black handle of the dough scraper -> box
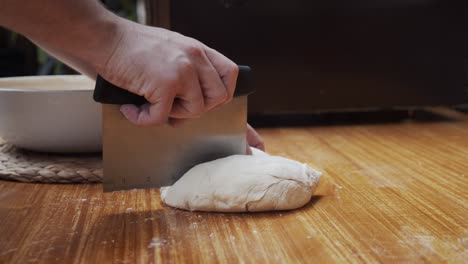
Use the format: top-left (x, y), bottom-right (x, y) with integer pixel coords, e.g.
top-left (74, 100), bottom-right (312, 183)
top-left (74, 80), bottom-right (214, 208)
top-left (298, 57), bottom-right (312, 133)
top-left (97, 21), bottom-right (239, 125)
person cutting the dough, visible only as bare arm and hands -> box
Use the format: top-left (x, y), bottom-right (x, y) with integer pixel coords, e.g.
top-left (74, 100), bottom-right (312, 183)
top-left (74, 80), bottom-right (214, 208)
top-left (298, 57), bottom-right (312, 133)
top-left (0, 0), bottom-right (263, 152)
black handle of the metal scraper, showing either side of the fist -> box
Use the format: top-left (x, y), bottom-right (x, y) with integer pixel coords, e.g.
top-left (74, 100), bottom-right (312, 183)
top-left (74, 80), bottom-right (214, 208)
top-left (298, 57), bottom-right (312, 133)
top-left (93, 65), bottom-right (254, 105)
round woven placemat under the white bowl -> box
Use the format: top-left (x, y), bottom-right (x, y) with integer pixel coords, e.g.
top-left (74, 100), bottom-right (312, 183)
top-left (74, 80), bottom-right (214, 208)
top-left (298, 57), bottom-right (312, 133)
top-left (0, 140), bottom-right (102, 183)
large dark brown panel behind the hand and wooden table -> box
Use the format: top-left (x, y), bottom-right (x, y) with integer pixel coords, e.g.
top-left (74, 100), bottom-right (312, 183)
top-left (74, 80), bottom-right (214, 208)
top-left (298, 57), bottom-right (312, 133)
top-left (170, 0), bottom-right (468, 114)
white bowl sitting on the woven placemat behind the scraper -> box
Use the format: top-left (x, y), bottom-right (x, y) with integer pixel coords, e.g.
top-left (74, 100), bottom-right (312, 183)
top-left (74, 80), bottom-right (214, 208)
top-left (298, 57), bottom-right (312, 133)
top-left (0, 75), bottom-right (102, 153)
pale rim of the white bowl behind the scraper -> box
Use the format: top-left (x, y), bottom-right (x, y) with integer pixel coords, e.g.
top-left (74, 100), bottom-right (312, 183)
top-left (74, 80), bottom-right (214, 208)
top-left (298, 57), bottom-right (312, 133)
top-left (0, 74), bottom-right (94, 93)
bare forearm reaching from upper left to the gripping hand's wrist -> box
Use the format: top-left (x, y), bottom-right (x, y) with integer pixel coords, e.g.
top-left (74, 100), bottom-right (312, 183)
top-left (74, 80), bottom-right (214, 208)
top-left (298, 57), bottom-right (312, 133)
top-left (0, 0), bottom-right (119, 72)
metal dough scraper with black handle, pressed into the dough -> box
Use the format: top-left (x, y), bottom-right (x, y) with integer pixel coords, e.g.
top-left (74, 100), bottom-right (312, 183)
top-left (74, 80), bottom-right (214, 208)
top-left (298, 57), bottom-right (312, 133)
top-left (94, 66), bottom-right (253, 192)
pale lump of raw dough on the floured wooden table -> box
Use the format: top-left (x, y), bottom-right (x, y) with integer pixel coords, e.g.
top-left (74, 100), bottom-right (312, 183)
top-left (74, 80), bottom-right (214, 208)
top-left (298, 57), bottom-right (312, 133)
top-left (161, 150), bottom-right (321, 212)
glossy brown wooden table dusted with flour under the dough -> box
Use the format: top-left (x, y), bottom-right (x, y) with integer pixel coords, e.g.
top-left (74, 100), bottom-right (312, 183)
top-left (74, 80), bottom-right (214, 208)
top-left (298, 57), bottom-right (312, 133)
top-left (0, 109), bottom-right (468, 263)
